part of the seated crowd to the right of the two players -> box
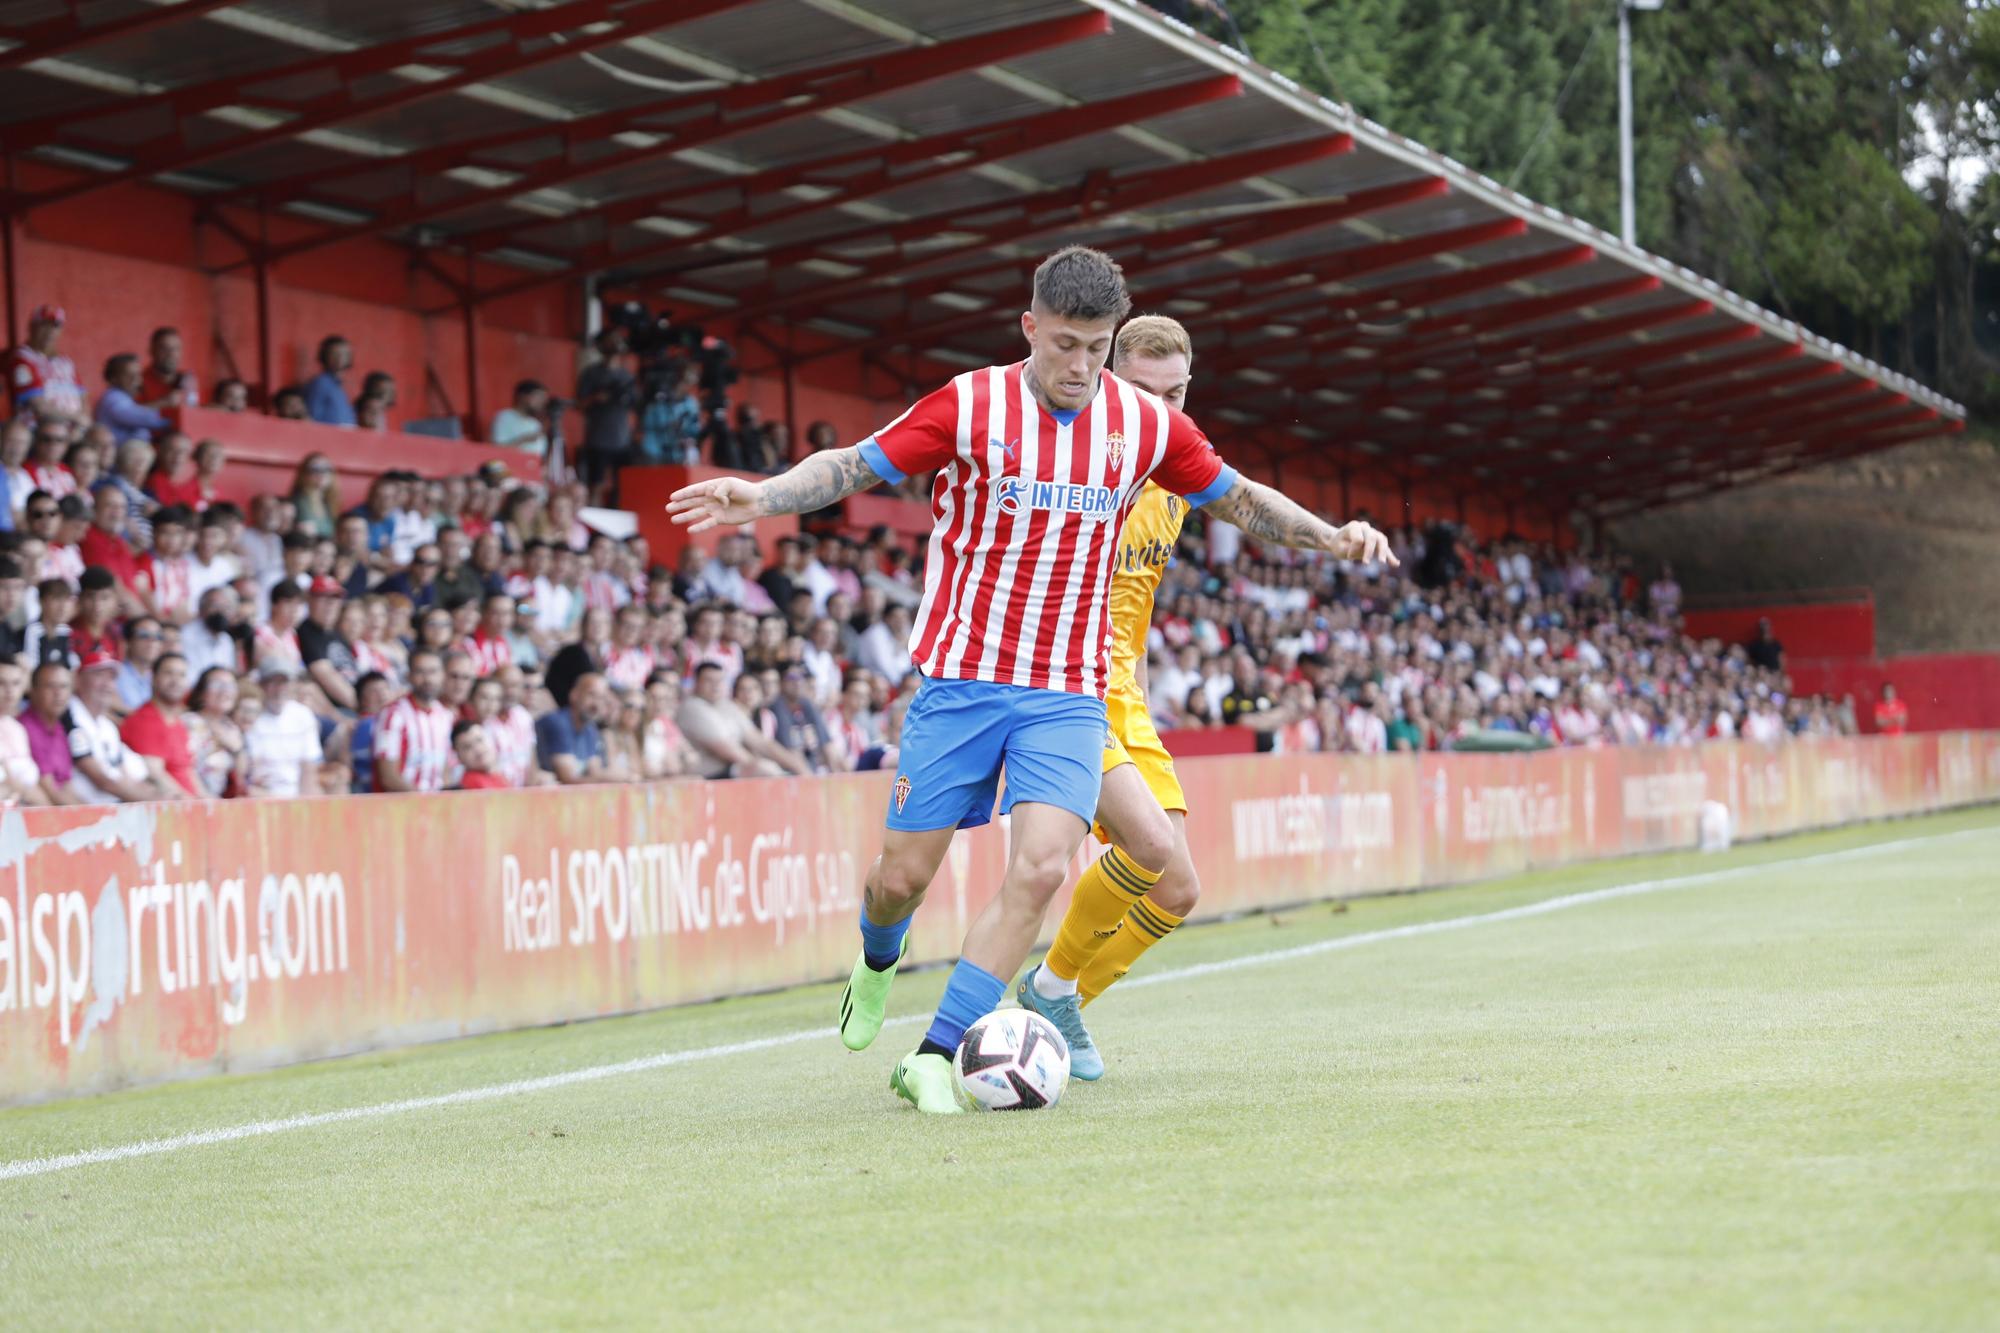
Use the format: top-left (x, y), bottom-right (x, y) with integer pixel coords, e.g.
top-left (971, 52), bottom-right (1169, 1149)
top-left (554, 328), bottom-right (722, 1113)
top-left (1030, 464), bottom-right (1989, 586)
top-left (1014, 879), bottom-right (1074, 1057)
top-left (1148, 514), bottom-right (1856, 753)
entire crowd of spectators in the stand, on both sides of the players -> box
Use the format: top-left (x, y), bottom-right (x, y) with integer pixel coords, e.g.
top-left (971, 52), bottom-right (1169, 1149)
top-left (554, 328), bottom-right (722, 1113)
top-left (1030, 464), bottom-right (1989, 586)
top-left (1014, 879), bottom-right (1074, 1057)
top-left (0, 306), bottom-right (1854, 805)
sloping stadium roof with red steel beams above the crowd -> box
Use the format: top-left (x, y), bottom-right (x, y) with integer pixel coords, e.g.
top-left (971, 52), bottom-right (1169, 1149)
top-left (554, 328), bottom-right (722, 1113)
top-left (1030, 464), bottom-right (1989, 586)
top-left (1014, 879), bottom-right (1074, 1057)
top-left (0, 0), bottom-right (1964, 514)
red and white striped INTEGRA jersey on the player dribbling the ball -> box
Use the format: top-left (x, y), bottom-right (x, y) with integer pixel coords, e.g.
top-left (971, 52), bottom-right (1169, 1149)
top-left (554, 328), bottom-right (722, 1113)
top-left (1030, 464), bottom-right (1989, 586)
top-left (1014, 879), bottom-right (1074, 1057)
top-left (860, 362), bottom-right (1236, 697)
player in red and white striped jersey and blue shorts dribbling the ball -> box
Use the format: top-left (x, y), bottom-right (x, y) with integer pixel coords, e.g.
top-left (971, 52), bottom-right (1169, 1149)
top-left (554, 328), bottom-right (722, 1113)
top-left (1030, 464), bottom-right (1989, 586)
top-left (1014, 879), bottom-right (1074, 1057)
top-left (668, 246), bottom-right (1388, 1113)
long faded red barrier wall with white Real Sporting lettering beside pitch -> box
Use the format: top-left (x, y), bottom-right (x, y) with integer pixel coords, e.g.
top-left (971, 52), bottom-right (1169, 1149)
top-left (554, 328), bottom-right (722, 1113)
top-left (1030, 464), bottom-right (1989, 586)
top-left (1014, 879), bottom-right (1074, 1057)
top-left (0, 733), bottom-right (2000, 1103)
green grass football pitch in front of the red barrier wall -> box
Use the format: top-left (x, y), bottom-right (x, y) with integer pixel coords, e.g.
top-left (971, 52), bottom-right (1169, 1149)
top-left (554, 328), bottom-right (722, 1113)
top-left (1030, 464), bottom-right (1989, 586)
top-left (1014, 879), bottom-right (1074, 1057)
top-left (0, 809), bottom-right (2000, 1333)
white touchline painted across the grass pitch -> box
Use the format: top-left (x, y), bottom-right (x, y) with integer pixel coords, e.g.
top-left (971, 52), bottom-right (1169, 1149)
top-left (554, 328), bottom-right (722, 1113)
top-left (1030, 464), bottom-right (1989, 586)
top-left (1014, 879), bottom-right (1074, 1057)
top-left (0, 829), bottom-right (1994, 1181)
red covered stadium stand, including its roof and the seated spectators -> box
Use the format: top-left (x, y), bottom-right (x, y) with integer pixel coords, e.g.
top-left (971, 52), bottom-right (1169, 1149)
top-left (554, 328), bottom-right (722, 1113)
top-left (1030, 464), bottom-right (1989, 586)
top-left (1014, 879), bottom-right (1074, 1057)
top-left (0, 0), bottom-right (1962, 801)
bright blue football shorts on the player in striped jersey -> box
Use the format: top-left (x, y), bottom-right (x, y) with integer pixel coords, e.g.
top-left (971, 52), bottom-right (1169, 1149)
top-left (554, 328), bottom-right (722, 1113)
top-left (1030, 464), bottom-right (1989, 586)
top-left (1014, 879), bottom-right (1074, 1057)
top-left (888, 677), bottom-right (1106, 833)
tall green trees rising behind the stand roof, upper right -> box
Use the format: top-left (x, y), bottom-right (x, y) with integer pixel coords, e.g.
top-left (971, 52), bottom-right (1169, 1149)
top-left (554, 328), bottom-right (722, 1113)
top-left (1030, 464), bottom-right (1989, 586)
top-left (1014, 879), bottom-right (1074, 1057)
top-left (1236, 0), bottom-right (2000, 406)
